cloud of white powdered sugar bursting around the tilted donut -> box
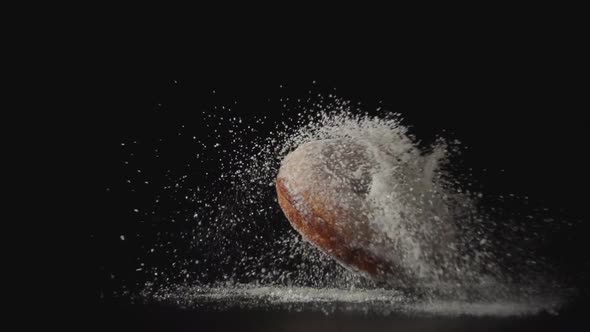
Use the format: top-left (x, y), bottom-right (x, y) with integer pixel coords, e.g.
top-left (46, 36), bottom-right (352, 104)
top-left (118, 97), bottom-right (563, 316)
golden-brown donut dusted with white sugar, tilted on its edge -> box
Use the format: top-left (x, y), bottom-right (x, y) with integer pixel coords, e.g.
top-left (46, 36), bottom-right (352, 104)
top-left (276, 139), bottom-right (403, 280)
